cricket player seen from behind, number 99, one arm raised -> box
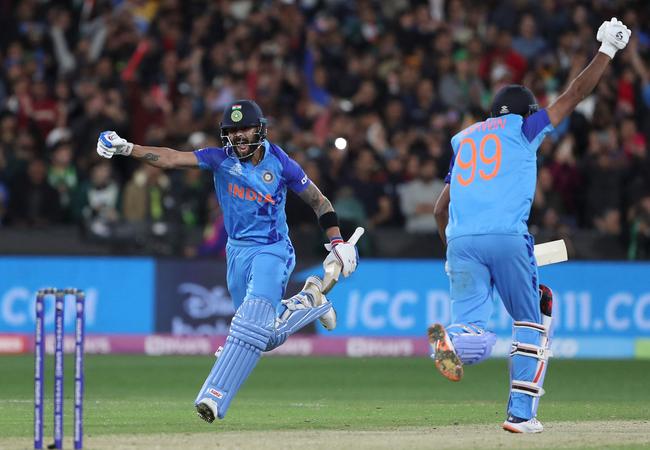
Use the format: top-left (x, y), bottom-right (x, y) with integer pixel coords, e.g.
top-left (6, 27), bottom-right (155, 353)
top-left (429, 18), bottom-right (631, 433)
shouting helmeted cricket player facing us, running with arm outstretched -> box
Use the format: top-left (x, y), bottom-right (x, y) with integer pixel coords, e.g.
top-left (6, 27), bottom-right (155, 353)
top-left (97, 100), bottom-right (358, 422)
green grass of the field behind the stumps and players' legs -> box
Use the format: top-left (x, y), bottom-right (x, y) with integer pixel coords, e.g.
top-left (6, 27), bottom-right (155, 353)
top-left (0, 355), bottom-right (650, 447)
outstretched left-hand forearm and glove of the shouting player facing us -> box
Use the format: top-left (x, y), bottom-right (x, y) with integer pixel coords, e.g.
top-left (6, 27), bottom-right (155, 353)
top-left (97, 131), bottom-right (199, 169)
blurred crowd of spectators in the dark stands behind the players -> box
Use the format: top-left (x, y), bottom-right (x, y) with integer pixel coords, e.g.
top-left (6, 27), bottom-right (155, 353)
top-left (0, 0), bottom-right (650, 259)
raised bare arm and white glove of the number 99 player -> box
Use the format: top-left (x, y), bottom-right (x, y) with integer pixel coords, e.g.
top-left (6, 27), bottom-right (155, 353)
top-left (546, 17), bottom-right (631, 127)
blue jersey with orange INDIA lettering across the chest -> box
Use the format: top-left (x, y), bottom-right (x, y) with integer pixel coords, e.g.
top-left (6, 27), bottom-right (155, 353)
top-left (194, 141), bottom-right (310, 244)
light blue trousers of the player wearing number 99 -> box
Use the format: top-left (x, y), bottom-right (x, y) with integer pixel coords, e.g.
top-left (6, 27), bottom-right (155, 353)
top-left (447, 235), bottom-right (541, 419)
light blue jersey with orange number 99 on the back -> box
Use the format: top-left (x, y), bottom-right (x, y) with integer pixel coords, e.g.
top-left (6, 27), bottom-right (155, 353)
top-left (445, 110), bottom-right (553, 240)
